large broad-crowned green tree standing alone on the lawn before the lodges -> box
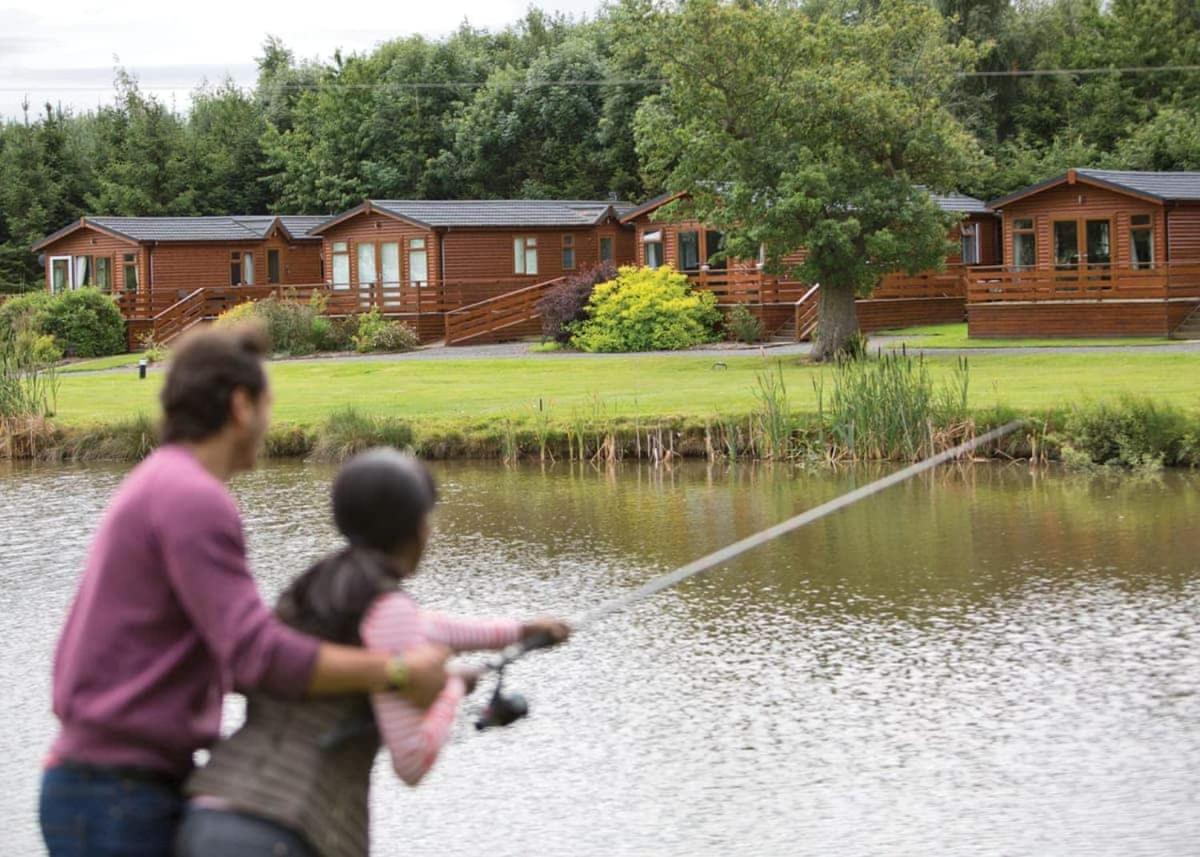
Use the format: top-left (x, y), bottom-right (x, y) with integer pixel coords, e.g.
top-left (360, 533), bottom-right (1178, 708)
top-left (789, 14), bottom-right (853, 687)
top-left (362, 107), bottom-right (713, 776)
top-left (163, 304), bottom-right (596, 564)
top-left (637, 0), bottom-right (980, 359)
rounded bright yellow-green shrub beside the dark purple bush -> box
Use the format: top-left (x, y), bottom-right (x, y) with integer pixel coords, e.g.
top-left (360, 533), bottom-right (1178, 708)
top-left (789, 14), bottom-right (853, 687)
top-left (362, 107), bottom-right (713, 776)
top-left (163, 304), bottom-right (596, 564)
top-left (571, 268), bottom-right (721, 352)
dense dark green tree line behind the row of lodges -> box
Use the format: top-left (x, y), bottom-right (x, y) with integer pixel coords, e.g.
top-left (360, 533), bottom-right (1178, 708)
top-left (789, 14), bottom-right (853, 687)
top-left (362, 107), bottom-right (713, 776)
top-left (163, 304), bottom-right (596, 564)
top-left (0, 0), bottom-right (1200, 289)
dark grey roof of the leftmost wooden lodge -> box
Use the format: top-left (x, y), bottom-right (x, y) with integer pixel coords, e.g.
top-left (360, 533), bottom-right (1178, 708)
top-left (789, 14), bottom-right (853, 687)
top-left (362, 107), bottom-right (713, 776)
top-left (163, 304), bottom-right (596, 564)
top-left (34, 215), bottom-right (326, 250)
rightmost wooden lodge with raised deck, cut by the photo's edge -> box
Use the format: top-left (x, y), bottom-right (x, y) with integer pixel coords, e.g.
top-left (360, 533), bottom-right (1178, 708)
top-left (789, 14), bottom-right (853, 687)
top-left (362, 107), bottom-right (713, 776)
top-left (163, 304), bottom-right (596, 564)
top-left (967, 169), bottom-right (1200, 336)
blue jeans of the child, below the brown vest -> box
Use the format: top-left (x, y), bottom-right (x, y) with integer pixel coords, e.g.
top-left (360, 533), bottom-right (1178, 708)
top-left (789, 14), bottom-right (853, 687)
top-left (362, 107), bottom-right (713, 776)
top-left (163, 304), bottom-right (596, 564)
top-left (175, 807), bottom-right (317, 857)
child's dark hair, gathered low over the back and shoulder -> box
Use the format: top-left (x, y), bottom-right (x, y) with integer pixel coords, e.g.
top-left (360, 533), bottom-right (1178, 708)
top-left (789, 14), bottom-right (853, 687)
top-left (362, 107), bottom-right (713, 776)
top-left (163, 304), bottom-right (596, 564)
top-left (276, 449), bottom-right (437, 645)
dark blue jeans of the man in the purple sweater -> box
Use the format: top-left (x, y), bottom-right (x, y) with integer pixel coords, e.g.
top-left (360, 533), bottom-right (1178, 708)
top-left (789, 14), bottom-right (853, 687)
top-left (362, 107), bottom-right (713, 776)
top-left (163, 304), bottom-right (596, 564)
top-left (38, 765), bottom-right (184, 857)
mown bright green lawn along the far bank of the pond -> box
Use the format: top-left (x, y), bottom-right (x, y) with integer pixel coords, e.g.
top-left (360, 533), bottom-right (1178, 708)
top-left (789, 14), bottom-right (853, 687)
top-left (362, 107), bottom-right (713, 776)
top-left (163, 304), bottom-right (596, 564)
top-left (49, 352), bottom-right (1200, 425)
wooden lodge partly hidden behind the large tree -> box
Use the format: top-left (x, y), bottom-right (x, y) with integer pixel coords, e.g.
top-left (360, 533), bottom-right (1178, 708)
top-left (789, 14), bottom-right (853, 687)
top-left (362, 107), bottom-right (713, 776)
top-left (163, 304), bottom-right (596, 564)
top-left (622, 193), bottom-right (1000, 338)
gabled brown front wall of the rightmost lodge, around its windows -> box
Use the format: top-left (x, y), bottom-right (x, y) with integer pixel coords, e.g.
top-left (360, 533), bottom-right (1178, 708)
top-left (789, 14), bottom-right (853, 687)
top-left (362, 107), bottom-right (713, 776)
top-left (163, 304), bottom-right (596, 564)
top-left (1002, 182), bottom-right (1169, 269)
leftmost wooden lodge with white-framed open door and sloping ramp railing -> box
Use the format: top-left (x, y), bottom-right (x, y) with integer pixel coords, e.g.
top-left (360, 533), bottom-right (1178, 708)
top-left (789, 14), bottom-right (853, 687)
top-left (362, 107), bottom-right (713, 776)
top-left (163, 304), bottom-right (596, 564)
top-left (32, 215), bottom-right (326, 346)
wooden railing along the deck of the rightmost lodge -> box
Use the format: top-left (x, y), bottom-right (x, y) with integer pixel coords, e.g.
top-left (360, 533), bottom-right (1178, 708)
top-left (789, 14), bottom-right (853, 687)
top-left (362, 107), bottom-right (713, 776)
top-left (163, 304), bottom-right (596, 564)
top-left (967, 263), bottom-right (1200, 304)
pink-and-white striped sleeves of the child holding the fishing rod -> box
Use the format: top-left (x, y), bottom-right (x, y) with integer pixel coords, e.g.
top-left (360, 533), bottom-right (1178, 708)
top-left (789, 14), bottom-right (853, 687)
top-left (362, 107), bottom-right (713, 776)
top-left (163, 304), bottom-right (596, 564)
top-left (360, 593), bottom-right (521, 785)
